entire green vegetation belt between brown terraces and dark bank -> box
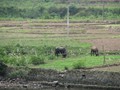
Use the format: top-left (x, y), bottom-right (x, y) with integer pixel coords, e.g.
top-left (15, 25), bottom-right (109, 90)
top-left (0, 39), bottom-right (120, 70)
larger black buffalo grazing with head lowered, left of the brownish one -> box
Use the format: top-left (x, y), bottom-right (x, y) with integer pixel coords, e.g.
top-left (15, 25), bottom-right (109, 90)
top-left (55, 47), bottom-right (67, 58)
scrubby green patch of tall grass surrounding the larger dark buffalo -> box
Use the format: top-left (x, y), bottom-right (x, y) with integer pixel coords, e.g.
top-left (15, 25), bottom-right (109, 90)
top-left (0, 39), bottom-right (91, 66)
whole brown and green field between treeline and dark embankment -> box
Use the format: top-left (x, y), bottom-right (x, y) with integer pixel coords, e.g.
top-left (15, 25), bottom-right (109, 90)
top-left (0, 20), bottom-right (120, 70)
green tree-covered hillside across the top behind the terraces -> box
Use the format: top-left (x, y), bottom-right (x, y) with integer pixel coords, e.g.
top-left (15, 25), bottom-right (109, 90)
top-left (0, 0), bottom-right (120, 19)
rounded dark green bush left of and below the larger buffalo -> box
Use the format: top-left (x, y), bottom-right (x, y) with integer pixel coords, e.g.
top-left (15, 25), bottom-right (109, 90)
top-left (31, 56), bottom-right (45, 65)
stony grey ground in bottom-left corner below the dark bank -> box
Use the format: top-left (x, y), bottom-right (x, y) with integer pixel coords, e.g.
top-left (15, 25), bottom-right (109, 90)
top-left (0, 78), bottom-right (51, 90)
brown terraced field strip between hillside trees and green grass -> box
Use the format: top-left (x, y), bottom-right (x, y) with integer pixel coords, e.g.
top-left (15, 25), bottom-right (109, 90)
top-left (0, 21), bottom-right (120, 50)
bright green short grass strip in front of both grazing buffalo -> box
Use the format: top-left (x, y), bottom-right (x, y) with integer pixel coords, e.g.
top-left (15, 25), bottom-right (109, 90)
top-left (32, 55), bottom-right (120, 70)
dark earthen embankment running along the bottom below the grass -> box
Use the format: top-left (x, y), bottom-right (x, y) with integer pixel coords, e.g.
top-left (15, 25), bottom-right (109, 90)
top-left (0, 68), bottom-right (120, 90)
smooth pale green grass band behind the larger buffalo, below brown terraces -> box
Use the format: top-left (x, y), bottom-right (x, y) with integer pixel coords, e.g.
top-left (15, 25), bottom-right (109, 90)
top-left (0, 35), bottom-right (90, 48)
